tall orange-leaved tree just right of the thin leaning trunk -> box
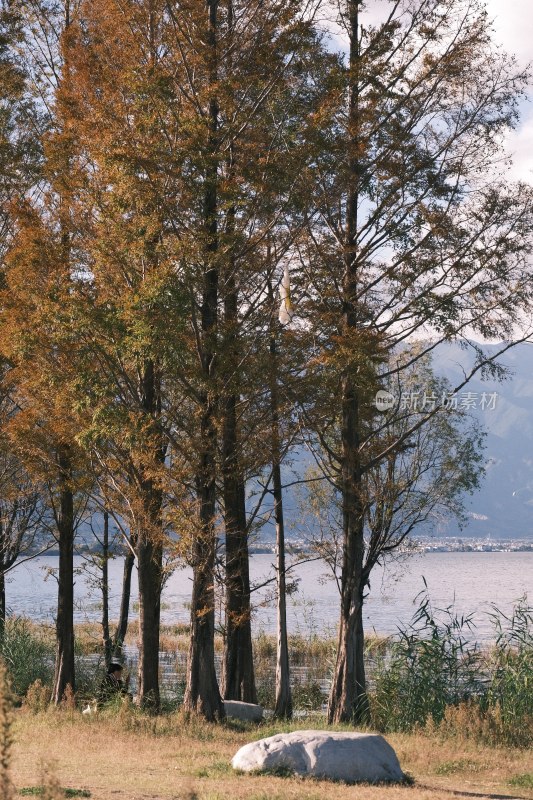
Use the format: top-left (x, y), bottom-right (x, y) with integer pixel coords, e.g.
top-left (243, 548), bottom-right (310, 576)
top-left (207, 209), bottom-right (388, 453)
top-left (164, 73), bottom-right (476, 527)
top-left (54, 2), bottom-right (180, 709)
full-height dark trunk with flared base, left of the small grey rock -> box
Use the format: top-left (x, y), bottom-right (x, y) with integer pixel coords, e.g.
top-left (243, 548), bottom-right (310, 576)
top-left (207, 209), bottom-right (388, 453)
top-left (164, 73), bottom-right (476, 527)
top-left (183, 0), bottom-right (224, 720)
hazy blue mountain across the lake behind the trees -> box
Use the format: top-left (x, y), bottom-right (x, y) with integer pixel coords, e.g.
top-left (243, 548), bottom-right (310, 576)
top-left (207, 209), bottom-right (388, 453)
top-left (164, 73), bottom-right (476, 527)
top-left (79, 344), bottom-right (533, 546)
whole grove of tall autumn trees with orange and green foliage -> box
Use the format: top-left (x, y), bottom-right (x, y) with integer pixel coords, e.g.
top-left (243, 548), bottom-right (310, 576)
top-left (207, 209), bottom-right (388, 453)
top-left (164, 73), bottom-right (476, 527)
top-left (0, 0), bottom-right (533, 722)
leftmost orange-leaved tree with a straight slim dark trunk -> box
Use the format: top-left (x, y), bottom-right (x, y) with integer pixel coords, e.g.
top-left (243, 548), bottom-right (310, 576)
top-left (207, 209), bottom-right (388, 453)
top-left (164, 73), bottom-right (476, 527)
top-left (1, 198), bottom-right (83, 703)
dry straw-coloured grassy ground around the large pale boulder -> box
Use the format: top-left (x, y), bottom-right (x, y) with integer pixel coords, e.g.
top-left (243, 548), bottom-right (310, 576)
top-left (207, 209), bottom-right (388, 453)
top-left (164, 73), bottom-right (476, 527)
top-left (8, 709), bottom-right (533, 800)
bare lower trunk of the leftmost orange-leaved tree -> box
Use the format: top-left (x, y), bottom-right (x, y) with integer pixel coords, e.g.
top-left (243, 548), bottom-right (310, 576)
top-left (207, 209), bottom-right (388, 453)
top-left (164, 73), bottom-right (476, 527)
top-left (52, 447), bottom-right (76, 705)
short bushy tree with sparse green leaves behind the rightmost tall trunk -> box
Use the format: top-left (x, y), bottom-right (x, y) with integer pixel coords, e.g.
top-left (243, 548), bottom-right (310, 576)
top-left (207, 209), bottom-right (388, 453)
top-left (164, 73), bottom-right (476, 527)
top-left (304, 350), bottom-right (483, 713)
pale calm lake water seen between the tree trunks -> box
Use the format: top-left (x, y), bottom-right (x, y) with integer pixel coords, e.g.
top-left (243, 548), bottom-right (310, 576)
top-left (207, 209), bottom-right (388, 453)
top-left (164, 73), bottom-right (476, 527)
top-left (6, 552), bottom-right (533, 639)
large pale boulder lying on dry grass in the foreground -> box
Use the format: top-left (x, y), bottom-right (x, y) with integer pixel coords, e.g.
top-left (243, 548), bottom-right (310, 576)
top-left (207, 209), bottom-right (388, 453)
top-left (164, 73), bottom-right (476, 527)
top-left (231, 731), bottom-right (404, 783)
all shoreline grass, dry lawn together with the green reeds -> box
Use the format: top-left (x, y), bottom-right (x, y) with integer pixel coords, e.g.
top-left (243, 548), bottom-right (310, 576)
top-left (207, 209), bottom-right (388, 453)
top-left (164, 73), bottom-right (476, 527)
top-left (0, 598), bottom-right (533, 800)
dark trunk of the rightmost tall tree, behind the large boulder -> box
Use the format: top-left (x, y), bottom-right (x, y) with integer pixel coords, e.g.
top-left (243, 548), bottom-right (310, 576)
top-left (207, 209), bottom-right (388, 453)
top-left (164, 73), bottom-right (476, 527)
top-left (328, 0), bottom-right (368, 723)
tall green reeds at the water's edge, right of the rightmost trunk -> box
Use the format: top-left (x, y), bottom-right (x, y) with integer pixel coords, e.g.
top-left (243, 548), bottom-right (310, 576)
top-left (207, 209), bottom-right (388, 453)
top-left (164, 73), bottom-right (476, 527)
top-left (371, 589), bottom-right (533, 747)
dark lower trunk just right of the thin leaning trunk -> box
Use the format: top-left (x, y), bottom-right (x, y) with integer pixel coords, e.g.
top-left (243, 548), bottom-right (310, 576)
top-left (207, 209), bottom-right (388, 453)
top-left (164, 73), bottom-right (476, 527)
top-left (137, 360), bottom-right (164, 711)
